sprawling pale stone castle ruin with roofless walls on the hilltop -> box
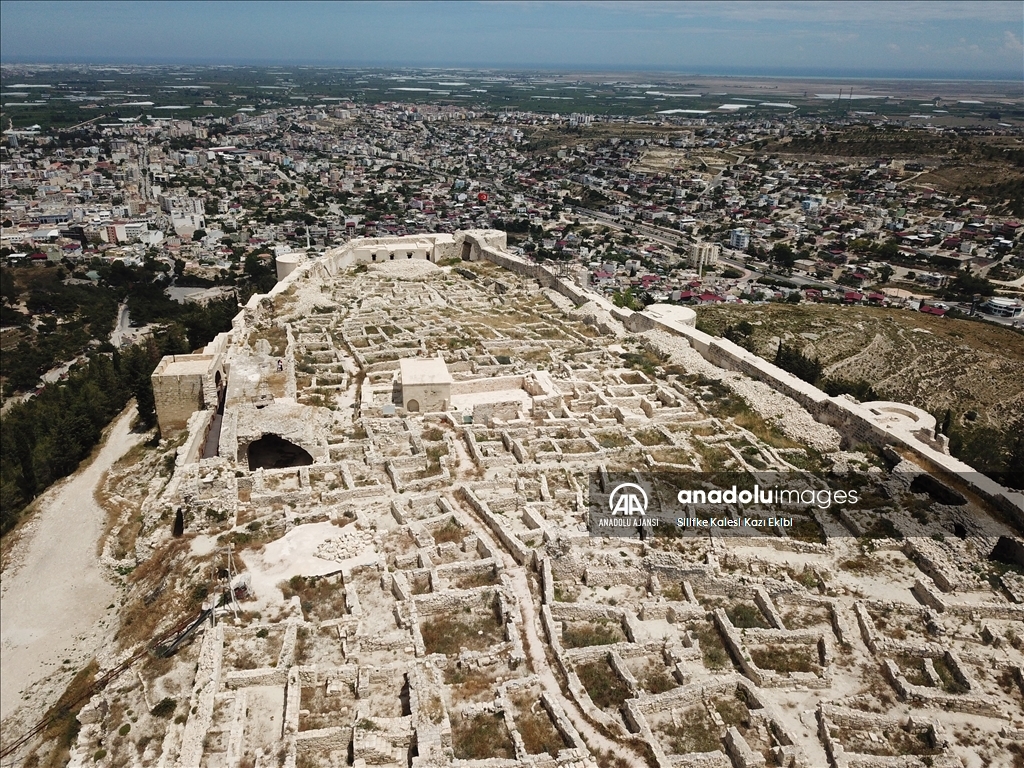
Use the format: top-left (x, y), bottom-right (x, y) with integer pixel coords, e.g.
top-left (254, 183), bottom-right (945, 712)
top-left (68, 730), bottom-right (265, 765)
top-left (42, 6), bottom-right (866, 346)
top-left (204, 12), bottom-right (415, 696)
top-left (58, 230), bottom-right (1024, 768)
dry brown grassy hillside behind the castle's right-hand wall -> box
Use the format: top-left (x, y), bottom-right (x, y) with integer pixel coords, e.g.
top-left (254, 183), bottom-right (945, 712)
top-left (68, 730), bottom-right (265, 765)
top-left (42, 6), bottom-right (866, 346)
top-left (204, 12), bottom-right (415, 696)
top-left (697, 304), bottom-right (1024, 485)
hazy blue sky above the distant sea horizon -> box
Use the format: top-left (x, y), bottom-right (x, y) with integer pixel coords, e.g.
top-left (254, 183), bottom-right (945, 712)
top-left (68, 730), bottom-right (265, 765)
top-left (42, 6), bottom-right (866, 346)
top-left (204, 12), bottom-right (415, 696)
top-left (0, 0), bottom-right (1024, 79)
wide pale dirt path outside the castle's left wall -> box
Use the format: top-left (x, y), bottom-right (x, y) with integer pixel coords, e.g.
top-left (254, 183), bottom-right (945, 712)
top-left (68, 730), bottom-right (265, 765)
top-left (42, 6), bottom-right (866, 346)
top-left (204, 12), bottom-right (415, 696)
top-left (0, 403), bottom-right (145, 719)
